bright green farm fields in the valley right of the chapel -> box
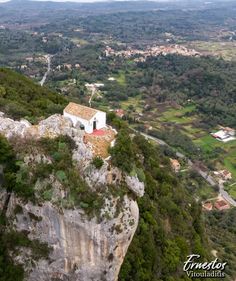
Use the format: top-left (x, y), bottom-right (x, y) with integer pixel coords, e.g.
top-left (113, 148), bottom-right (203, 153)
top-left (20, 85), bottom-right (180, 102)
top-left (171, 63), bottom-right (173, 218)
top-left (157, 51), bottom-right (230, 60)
top-left (135, 102), bottom-right (236, 179)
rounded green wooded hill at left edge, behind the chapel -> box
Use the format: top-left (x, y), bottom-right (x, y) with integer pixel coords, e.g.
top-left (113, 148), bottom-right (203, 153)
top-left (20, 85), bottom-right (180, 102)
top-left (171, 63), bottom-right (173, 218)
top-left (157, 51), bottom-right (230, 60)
top-left (0, 68), bottom-right (66, 122)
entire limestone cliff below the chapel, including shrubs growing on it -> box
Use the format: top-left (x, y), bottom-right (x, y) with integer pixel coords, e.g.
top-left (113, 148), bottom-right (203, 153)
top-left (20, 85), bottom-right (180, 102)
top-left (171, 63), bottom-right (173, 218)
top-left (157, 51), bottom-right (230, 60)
top-left (0, 113), bottom-right (144, 281)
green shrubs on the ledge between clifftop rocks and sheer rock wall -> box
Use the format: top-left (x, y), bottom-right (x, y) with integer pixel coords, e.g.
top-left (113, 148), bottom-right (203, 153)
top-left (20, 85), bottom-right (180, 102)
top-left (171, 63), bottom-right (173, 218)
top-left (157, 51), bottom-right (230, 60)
top-left (9, 136), bottom-right (103, 215)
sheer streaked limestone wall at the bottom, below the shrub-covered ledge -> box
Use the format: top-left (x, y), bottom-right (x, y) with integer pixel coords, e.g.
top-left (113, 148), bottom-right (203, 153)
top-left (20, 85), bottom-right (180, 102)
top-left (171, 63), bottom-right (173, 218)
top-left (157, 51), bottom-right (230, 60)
top-left (7, 192), bottom-right (139, 281)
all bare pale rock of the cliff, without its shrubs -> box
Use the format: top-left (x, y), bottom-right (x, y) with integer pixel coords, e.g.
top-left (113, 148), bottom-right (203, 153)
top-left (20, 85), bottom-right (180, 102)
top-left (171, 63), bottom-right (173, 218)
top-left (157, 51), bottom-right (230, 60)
top-left (0, 114), bottom-right (144, 281)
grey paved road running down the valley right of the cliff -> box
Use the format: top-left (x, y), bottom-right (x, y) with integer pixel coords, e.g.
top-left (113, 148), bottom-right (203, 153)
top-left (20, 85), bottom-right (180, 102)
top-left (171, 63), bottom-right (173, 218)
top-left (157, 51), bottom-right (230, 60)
top-left (132, 129), bottom-right (236, 207)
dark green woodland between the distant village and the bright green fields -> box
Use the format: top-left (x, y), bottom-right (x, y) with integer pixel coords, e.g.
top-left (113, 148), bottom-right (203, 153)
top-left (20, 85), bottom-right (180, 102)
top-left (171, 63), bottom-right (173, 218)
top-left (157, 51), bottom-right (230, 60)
top-left (139, 55), bottom-right (236, 127)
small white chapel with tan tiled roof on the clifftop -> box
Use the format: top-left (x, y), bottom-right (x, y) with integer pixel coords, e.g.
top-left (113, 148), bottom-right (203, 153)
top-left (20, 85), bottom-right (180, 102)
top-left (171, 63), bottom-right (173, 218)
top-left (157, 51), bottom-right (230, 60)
top-left (63, 102), bottom-right (106, 134)
